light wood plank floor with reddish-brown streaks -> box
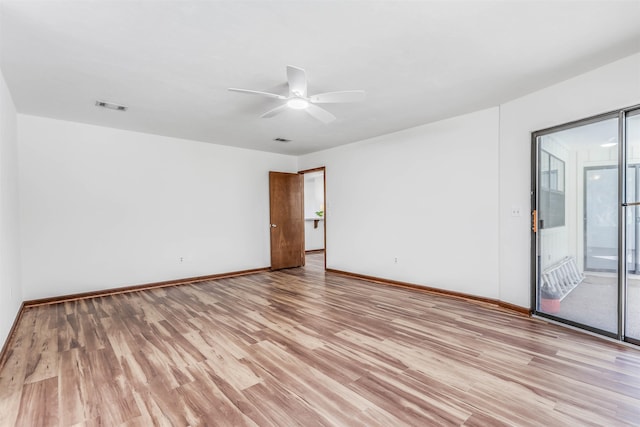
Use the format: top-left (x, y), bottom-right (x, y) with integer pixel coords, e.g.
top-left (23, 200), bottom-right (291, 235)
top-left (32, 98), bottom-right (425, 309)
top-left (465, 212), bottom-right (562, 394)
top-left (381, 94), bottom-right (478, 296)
top-left (0, 254), bottom-right (640, 426)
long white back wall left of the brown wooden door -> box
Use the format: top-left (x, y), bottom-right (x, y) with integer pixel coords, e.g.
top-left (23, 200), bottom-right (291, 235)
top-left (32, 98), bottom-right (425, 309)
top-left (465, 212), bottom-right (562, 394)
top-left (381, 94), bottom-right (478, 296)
top-left (18, 112), bottom-right (297, 300)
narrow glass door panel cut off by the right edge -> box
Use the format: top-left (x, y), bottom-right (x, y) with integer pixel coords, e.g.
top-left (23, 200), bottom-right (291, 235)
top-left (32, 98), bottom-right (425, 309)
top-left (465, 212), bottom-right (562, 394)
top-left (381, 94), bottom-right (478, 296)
top-left (624, 110), bottom-right (640, 344)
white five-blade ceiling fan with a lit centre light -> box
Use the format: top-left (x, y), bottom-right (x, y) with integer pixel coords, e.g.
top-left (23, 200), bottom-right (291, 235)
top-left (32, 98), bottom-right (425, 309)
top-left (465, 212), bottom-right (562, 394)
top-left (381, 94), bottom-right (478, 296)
top-left (229, 65), bottom-right (366, 124)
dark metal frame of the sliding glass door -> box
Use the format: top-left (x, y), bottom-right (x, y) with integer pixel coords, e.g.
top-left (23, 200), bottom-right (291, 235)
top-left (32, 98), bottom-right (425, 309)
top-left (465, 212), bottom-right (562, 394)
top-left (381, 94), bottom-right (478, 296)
top-left (530, 105), bottom-right (640, 345)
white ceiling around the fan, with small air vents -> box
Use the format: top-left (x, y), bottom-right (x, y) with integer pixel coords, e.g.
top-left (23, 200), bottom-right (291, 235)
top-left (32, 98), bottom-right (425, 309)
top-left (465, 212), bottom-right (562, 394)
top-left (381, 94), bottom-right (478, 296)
top-left (0, 0), bottom-right (640, 155)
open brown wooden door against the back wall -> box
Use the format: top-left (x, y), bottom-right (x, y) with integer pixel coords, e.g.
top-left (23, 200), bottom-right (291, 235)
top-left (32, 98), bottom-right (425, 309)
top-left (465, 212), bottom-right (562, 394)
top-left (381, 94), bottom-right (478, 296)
top-left (269, 172), bottom-right (304, 270)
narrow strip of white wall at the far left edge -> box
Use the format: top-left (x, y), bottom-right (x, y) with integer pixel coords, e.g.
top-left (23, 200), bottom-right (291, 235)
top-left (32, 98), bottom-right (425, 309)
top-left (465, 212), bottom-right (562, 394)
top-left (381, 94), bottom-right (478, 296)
top-left (0, 67), bottom-right (23, 348)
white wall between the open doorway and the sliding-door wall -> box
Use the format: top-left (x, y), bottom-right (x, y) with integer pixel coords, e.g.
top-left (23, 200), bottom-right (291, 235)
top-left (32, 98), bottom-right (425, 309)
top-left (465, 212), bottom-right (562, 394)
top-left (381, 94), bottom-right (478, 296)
top-left (299, 108), bottom-right (499, 298)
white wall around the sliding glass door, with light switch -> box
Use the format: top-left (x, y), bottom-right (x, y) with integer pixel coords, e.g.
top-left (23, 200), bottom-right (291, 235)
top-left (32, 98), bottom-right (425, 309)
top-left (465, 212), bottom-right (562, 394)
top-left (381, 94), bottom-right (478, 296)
top-left (500, 54), bottom-right (640, 307)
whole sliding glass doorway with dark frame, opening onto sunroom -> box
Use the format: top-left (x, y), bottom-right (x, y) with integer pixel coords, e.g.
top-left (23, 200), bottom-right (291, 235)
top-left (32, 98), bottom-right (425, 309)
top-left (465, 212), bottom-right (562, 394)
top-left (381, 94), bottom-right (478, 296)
top-left (532, 107), bottom-right (640, 344)
